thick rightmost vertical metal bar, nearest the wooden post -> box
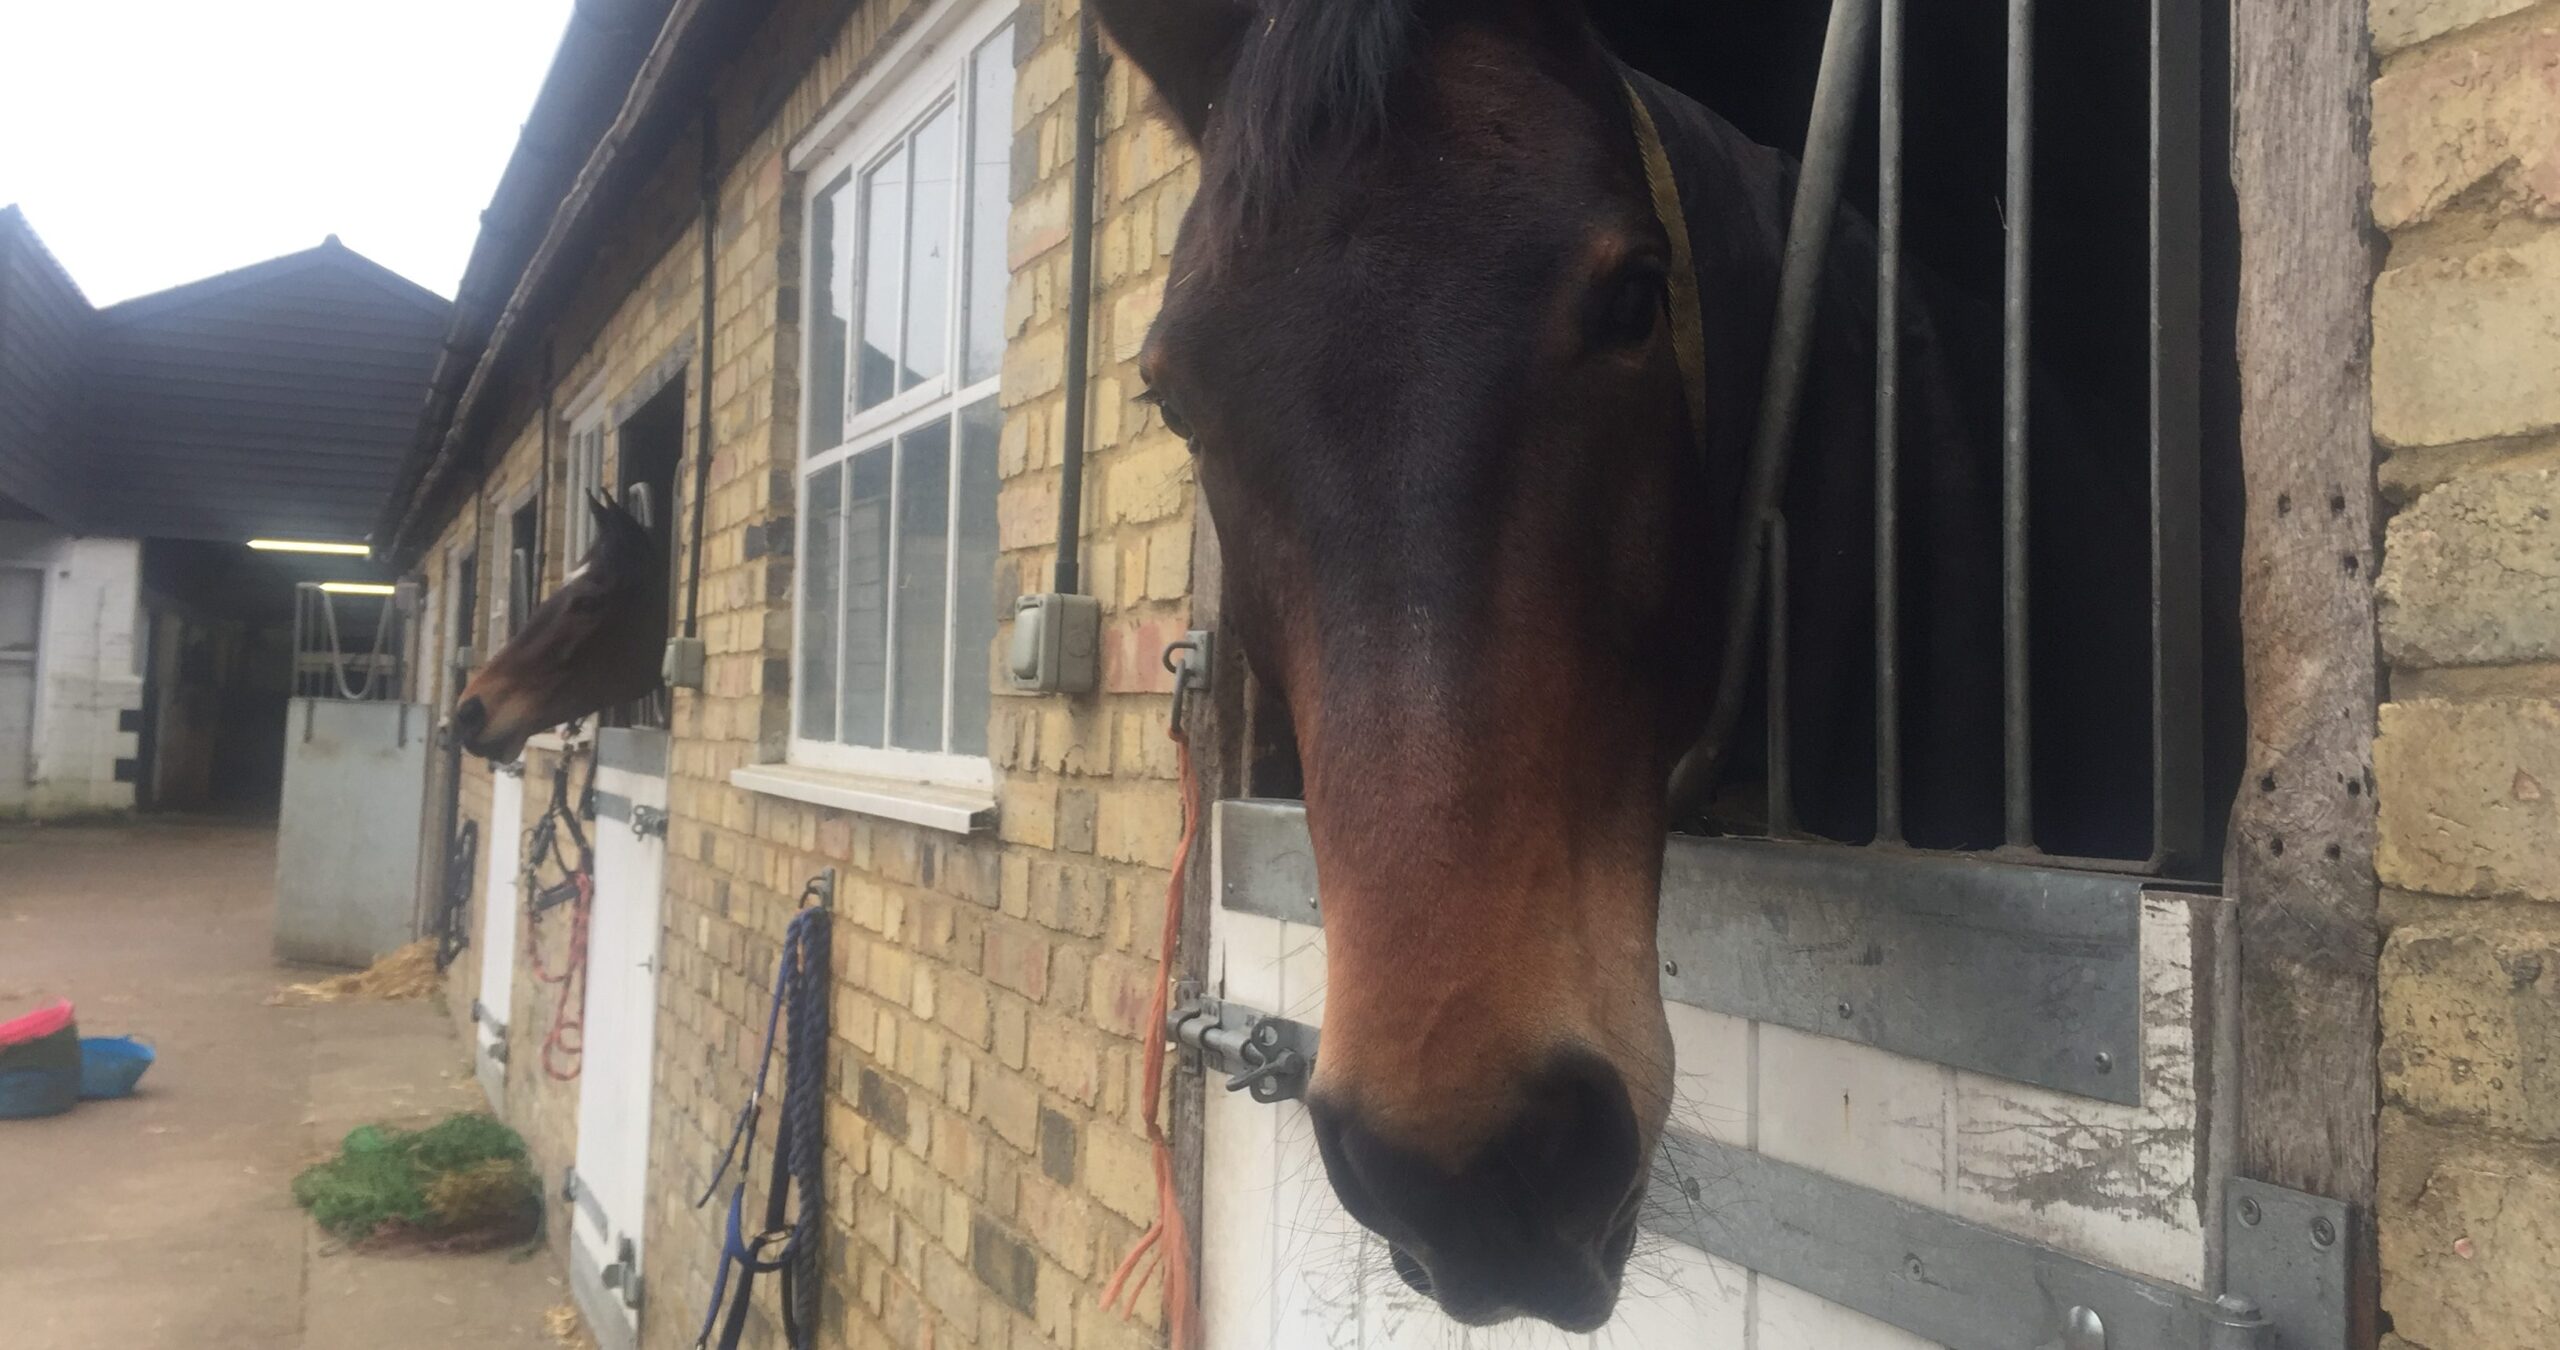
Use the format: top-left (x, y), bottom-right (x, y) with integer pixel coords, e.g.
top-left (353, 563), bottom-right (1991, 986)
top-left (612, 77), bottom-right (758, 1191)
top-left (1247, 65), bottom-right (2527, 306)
top-left (2150, 0), bottom-right (2204, 871)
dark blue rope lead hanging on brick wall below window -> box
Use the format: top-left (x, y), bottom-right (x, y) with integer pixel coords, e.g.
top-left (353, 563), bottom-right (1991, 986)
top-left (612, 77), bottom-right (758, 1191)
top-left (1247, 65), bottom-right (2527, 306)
top-left (694, 886), bottom-right (832, 1350)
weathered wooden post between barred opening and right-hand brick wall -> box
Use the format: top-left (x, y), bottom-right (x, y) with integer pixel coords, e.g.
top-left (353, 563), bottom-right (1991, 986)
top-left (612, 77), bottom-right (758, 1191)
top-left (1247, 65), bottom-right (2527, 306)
top-left (2225, 0), bottom-right (2378, 1347)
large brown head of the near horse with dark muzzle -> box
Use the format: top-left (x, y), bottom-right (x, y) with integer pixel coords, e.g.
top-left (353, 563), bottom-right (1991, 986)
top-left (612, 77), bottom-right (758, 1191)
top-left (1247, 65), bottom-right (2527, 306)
top-left (1096, 0), bottom-right (1746, 1327)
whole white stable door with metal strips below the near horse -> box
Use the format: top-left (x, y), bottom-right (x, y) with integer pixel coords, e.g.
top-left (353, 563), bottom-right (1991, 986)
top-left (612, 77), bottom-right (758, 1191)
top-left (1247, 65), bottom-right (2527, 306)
top-left (1183, 802), bottom-right (2263, 1350)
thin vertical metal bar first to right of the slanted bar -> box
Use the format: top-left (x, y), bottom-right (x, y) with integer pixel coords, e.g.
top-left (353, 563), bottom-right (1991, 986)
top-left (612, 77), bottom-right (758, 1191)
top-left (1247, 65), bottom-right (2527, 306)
top-left (1876, 0), bottom-right (1902, 843)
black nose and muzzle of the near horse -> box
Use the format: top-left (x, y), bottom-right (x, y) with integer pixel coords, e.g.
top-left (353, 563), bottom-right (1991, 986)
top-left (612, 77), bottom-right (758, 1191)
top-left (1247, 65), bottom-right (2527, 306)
top-left (1311, 1050), bottom-right (1644, 1332)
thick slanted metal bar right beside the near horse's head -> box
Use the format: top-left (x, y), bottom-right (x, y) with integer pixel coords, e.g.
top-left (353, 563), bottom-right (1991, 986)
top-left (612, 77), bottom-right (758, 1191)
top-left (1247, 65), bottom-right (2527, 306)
top-left (1672, 0), bottom-right (1876, 817)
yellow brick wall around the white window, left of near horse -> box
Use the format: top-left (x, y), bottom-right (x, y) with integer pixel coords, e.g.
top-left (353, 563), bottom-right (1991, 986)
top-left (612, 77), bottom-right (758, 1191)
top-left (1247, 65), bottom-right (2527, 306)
top-left (401, 0), bottom-right (1193, 1347)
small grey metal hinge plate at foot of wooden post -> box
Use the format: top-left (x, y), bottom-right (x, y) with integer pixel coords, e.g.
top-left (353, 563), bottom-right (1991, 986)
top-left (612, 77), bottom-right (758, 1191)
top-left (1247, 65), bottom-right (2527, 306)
top-left (2222, 1176), bottom-right (2355, 1350)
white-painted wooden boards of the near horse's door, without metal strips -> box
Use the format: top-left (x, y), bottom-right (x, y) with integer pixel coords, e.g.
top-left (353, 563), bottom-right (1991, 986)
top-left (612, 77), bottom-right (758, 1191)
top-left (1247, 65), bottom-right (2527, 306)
top-left (1201, 804), bottom-right (2220, 1350)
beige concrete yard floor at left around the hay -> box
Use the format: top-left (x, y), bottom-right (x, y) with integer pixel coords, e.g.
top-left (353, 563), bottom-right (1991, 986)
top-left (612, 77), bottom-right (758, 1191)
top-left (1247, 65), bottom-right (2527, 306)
top-left (0, 822), bottom-right (568, 1350)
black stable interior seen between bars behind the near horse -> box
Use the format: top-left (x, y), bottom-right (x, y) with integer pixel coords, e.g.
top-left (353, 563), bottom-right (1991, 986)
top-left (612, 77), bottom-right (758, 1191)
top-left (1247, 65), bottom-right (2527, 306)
top-left (1252, 0), bottom-right (2245, 879)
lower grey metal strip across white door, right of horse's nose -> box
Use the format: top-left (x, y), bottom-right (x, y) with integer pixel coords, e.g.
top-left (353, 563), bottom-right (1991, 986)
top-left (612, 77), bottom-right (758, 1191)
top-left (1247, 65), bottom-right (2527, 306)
top-left (1644, 1130), bottom-right (2222, 1350)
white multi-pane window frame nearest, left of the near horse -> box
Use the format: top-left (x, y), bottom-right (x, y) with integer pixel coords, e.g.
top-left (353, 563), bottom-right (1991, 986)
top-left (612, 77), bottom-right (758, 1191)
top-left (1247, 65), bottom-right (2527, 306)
top-left (786, 0), bottom-right (1021, 789)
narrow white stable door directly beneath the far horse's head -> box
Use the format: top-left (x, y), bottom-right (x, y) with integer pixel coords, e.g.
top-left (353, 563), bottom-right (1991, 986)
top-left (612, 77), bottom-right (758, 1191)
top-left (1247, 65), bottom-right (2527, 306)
top-left (571, 728), bottom-right (666, 1350)
